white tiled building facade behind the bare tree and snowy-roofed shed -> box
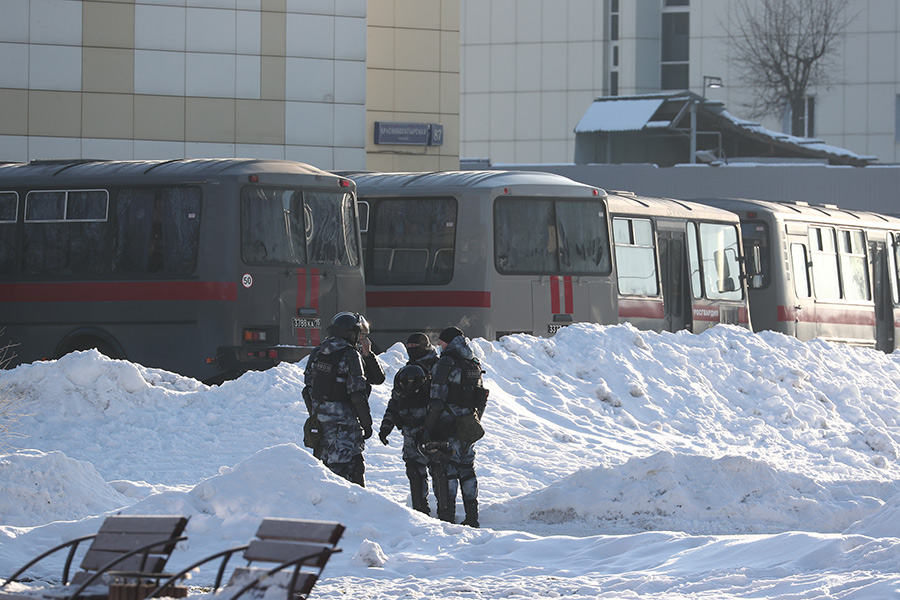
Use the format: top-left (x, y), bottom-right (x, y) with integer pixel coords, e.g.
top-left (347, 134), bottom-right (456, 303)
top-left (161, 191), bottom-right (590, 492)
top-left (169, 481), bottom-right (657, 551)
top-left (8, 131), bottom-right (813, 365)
top-left (460, 0), bottom-right (900, 163)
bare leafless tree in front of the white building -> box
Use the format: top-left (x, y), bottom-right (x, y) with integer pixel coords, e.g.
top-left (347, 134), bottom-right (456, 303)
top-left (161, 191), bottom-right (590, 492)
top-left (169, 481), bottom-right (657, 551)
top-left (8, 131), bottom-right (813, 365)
top-left (728, 0), bottom-right (853, 136)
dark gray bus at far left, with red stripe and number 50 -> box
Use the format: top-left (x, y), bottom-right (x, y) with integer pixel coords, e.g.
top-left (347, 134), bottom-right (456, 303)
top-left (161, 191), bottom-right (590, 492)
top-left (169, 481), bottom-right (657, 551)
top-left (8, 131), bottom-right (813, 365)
top-left (0, 159), bottom-right (365, 382)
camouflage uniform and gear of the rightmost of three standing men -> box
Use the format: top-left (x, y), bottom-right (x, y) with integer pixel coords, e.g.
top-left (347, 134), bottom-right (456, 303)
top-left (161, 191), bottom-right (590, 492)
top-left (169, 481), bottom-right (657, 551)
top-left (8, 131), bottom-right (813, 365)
top-left (426, 335), bottom-right (485, 527)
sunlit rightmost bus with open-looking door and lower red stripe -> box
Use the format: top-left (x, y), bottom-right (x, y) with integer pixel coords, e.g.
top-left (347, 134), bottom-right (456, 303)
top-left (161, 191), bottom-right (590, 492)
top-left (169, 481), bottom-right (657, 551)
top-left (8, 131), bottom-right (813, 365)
top-left (698, 198), bottom-right (900, 352)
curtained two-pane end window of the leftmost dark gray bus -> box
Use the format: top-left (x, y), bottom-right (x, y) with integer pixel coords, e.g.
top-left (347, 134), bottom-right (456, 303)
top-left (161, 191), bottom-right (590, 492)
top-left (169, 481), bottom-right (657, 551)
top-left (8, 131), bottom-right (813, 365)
top-left (241, 187), bottom-right (359, 267)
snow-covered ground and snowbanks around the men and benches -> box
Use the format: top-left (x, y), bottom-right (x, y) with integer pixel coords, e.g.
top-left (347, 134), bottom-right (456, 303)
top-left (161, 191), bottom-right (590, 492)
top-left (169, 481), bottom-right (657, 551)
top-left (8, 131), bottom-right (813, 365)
top-left (0, 324), bottom-right (900, 600)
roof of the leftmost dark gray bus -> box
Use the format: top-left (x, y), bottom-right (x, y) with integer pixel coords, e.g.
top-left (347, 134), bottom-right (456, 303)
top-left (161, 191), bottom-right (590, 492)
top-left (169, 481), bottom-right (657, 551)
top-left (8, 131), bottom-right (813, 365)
top-left (0, 158), bottom-right (335, 183)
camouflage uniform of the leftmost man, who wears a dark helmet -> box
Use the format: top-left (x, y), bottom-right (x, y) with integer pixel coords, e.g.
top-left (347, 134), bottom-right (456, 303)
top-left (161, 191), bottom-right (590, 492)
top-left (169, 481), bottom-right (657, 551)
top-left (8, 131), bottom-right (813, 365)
top-left (304, 337), bottom-right (372, 485)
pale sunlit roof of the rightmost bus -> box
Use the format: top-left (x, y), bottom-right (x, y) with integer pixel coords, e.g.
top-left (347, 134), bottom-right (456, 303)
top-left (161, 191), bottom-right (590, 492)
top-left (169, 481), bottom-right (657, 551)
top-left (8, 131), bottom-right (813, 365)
top-left (694, 198), bottom-right (900, 229)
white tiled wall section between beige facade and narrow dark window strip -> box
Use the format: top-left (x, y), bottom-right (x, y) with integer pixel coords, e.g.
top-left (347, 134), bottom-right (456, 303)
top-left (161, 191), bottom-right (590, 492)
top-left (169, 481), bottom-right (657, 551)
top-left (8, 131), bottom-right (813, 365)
top-left (460, 0), bottom-right (604, 162)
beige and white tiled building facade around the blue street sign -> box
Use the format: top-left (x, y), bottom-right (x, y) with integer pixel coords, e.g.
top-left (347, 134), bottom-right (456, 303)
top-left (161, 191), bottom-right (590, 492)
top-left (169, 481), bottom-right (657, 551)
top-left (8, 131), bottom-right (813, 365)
top-left (0, 0), bottom-right (459, 170)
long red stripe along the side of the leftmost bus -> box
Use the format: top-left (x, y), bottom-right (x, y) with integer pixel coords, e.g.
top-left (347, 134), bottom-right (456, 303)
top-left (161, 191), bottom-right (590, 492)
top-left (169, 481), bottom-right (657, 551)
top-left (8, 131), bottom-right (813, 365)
top-left (0, 281), bottom-right (237, 302)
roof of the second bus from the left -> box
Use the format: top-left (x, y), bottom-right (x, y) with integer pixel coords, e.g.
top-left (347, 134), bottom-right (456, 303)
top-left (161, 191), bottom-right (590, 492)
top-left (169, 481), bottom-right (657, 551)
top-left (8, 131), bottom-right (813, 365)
top-left (341, 171), bottom-right (605, 196)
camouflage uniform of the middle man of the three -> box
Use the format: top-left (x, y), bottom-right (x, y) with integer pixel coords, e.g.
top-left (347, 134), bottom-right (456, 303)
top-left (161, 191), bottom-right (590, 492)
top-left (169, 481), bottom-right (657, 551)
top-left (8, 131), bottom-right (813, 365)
top-left (378, 349), bottom-right (438, 514)
